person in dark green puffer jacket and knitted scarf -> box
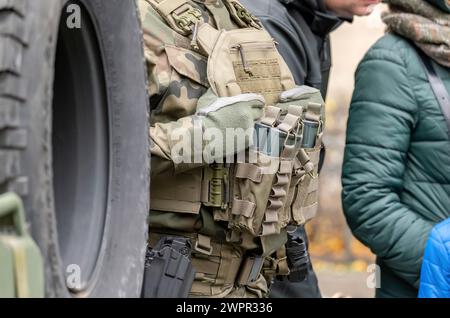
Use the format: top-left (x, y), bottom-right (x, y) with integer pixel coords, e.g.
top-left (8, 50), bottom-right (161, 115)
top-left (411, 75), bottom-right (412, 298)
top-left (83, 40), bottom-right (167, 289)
top-left (342, 0), bottom-right (450, 297)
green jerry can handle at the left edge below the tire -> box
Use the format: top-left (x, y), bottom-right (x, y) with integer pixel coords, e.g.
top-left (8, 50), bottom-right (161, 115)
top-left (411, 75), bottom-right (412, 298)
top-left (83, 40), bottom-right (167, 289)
top-left (0, 193), bottom-right (27, 236)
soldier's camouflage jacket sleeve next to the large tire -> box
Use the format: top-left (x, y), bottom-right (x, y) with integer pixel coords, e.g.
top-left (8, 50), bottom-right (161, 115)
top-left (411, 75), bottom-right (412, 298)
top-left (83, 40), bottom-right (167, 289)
top-left (139, 0), bottom-right (207, 175)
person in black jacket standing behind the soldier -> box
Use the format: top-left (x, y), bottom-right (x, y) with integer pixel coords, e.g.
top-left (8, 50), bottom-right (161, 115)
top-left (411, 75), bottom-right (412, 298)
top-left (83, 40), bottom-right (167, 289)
top-left (241, 0), bottom-right (381, 298)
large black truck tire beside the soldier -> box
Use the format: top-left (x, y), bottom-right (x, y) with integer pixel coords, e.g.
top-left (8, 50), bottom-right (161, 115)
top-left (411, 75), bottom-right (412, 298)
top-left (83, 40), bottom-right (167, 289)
top-left (0, 0), bottom-right (150, 297)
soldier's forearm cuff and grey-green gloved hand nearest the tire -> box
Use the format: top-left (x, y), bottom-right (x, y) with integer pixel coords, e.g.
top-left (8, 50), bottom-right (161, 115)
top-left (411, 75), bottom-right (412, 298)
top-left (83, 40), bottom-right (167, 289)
top-left (150, 90), bottom-right (265, 173)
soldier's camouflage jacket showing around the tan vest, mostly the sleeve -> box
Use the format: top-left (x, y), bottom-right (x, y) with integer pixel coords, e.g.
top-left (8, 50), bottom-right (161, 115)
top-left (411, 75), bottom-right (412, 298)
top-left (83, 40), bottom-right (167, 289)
top-left (139, 0), bottom-right (250, 174)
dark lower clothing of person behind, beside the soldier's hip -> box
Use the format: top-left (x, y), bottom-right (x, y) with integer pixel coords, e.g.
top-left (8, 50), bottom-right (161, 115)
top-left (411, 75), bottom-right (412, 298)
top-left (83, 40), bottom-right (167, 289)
top-left (269, 226), bottom-right (322, 298)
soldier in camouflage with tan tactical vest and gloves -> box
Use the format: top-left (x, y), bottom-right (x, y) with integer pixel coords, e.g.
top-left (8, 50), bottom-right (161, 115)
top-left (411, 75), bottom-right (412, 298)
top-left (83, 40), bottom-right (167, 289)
top-left (139, 0), bottom-right (324, 297)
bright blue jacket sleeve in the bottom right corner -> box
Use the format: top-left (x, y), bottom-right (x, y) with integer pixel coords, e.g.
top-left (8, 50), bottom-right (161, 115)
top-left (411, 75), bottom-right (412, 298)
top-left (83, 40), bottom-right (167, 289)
top-left (419, 229), bottom-right (450, 298)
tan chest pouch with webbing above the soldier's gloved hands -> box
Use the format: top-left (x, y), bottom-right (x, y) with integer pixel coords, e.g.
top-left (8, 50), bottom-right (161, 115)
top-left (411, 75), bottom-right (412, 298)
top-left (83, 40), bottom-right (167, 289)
top-left (197, 23), bottom-right (295, 105)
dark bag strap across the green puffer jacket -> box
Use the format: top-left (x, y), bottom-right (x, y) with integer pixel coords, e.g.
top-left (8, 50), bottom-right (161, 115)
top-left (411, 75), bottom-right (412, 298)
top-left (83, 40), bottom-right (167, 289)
top-left (417, 48), bottom-right (450, 137)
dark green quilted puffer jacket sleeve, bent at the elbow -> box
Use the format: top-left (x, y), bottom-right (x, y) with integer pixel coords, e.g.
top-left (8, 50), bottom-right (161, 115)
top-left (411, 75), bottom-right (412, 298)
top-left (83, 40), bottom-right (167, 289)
top-left (342, 48), bottom-right (432, 288)
